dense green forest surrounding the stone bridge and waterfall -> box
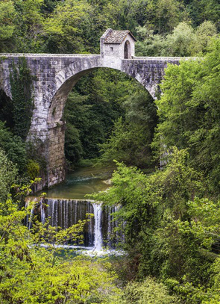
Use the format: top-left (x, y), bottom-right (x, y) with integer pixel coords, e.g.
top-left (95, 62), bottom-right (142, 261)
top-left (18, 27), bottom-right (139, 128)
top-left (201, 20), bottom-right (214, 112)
top-left (0, 0), bottom-right (220, 304)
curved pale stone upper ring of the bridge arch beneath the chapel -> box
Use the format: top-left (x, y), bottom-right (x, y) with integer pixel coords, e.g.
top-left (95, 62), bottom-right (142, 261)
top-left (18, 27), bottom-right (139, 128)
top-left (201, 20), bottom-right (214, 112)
top-left (47, 55), bottom-right (161, 127)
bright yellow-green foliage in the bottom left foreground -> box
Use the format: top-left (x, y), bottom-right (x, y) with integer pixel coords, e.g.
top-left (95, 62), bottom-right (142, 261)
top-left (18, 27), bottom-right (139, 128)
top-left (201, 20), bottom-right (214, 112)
top-left (0, 182), bottom-right (118, 304)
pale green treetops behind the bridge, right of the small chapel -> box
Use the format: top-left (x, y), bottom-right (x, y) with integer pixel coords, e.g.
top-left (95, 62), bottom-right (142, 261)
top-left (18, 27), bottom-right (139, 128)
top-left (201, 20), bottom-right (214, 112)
top-left (136, 21), bottom-right (217, 57)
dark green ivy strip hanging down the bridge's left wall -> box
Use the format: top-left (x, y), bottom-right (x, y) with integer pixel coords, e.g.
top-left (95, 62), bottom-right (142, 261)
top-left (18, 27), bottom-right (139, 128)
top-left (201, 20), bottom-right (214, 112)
top-left (10, 57), bottom-right (33, 140)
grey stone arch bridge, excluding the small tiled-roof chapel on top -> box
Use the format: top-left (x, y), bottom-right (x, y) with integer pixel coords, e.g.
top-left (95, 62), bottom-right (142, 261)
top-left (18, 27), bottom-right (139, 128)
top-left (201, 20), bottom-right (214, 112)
top-left (0, 53), bottom-right (182, 186)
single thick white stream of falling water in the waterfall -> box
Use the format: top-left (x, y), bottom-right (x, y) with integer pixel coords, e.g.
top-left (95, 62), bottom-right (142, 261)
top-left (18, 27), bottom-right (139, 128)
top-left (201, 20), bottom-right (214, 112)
top-left (92, 203), bottom-right (102, 251)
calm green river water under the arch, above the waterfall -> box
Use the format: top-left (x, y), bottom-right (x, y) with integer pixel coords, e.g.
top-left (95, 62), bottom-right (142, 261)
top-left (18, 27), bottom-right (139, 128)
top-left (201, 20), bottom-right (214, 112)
top-left (45, 167), bottom-right (114, 199)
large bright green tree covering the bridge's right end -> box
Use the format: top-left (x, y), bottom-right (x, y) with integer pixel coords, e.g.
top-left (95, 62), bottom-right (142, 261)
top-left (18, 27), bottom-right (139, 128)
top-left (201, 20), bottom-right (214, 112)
top-left (155, 39), bottom-right (220, 191)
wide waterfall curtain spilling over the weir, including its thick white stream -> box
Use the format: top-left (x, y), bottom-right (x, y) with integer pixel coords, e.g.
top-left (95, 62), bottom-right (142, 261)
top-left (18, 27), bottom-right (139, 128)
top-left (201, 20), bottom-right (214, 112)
top-left (31, 199), bottom-right (122, 252)
